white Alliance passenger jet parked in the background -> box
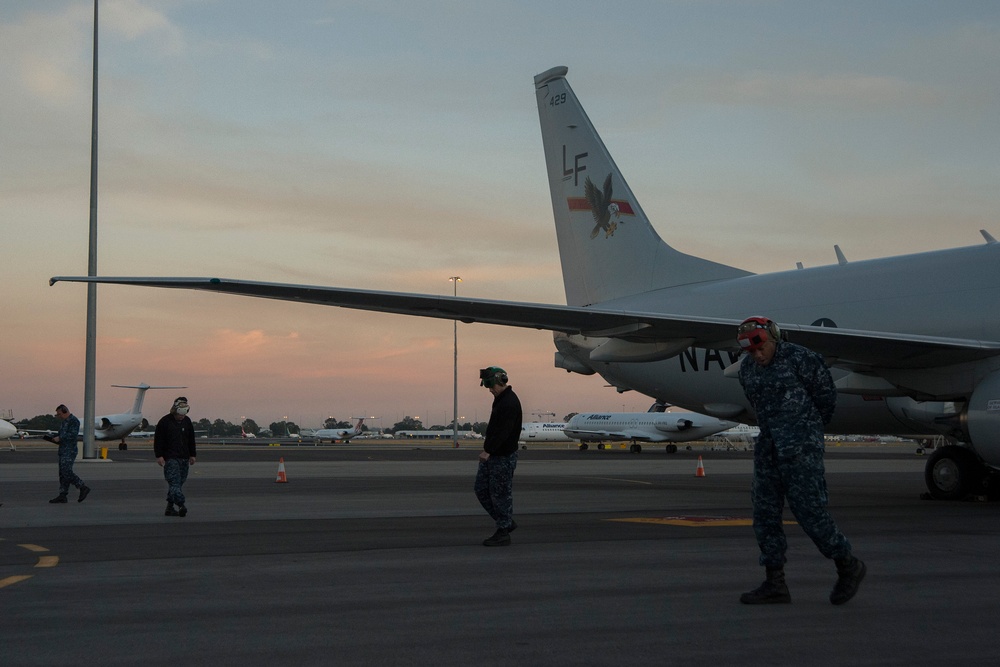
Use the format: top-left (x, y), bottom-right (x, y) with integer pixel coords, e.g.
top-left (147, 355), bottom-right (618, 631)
top-left (565, 403), bottom-right (737, 454)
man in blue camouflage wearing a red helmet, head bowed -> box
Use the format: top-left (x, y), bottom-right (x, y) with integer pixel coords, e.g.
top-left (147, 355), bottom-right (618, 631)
top-left (737, 317), bottom-right (866, 605)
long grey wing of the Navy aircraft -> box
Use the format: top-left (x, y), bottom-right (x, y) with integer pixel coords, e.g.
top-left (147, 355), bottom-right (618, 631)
top-left (49, 276), bottom-right (1000, 368)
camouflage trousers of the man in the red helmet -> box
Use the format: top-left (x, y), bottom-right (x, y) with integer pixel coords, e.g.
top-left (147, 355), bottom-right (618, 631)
top-left (750, 451), bottom-right (851, 567)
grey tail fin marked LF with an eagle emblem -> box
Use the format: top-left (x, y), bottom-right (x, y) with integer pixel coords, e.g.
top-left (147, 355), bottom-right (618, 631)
top-left (535, 67), bottom-right (750, 306)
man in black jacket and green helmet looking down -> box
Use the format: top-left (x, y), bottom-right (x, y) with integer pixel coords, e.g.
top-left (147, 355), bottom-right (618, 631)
top-left (475, 366), bottom-right (521, 547)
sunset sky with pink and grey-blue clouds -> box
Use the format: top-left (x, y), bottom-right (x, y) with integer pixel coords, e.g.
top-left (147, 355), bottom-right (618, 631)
top-left (0, 0), bottom-right (1000, 427)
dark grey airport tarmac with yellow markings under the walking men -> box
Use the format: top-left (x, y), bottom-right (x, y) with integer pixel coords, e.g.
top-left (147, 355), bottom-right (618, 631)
top-left (0, 443), bottom-right (1000, 667)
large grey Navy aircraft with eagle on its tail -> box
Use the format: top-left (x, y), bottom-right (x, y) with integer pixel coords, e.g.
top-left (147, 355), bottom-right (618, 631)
top-left (50, 67), bottom-right (1000, 498)
